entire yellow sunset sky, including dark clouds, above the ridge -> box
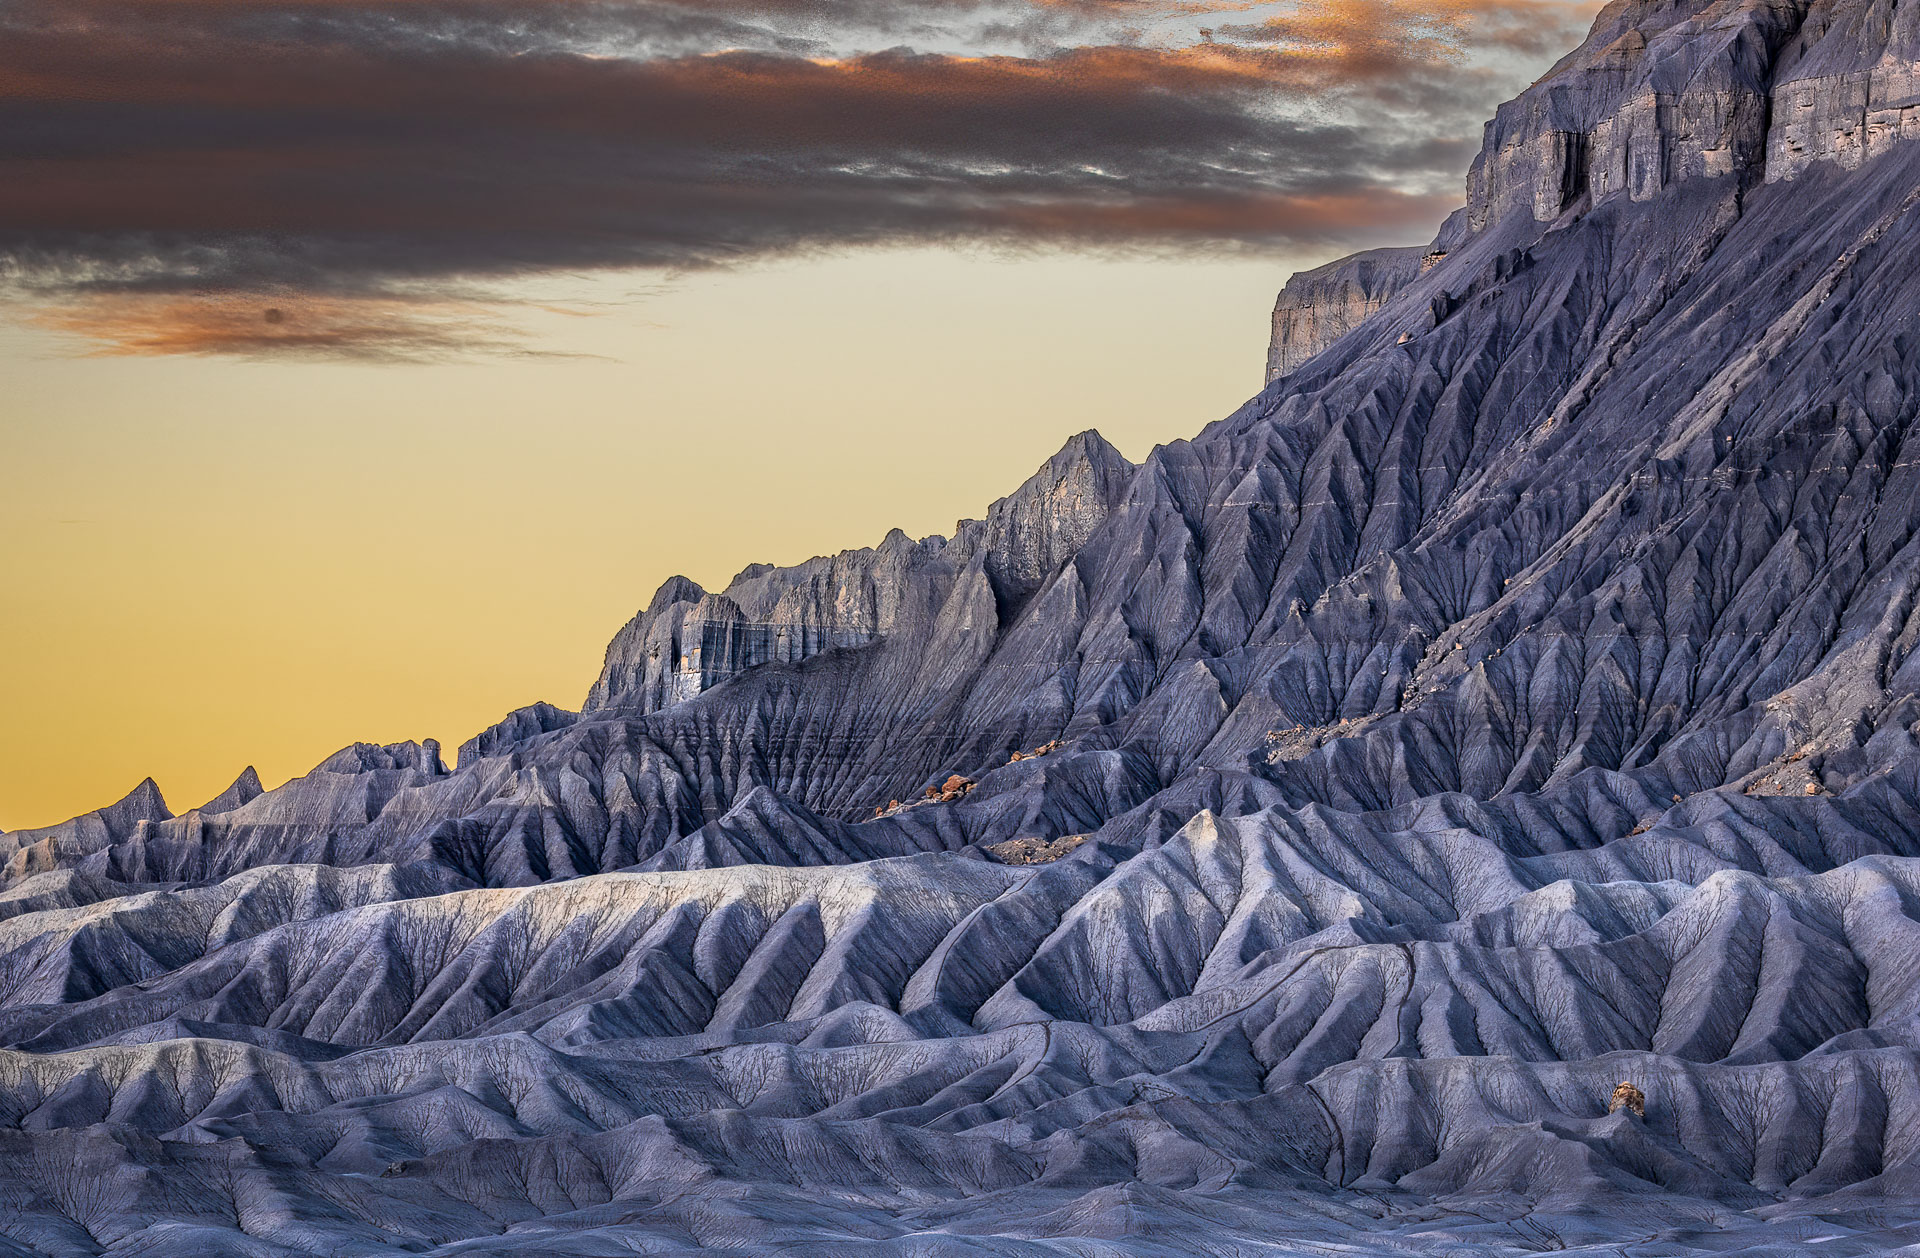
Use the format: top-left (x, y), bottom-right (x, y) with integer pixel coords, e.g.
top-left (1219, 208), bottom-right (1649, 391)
top-left (0, 0), bottom-right (1592, 830)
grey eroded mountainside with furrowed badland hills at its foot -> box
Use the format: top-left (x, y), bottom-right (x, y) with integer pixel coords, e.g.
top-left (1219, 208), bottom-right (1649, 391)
top-left (11, 0), bottom-right (1920, 1258)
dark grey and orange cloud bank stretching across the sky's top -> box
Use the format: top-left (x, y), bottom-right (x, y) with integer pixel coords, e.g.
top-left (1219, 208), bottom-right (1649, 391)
top-left (0, 0), bottom-right (1572, 355)
